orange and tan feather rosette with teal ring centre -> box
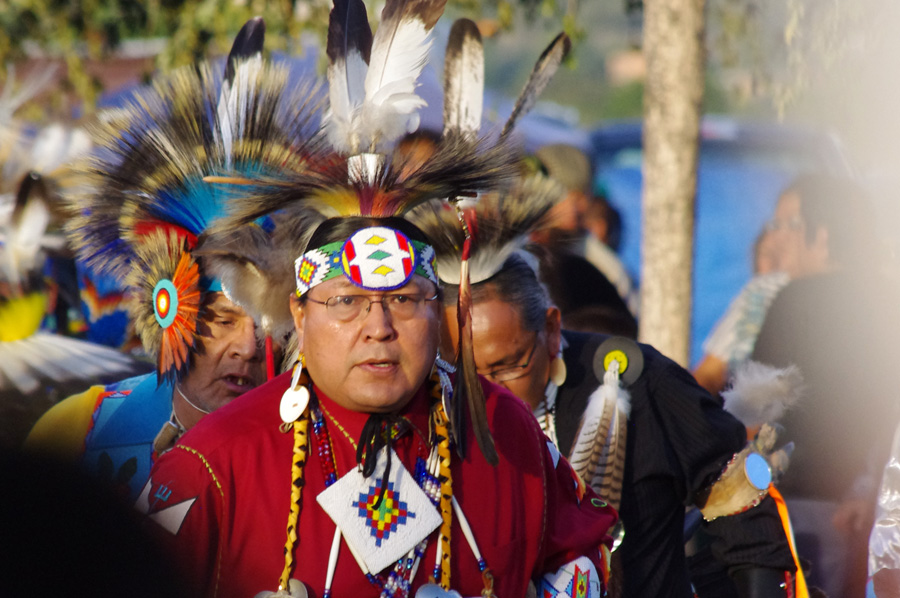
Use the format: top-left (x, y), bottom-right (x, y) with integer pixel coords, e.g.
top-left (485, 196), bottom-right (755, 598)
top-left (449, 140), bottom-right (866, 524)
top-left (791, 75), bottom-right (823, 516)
top-left (126, 230), bottom-right (201, 381)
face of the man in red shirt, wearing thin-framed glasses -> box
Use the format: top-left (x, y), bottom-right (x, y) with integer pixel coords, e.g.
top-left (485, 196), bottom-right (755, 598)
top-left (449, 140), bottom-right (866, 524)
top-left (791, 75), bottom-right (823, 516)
top-left (291, 276), bottom-right (440, 413)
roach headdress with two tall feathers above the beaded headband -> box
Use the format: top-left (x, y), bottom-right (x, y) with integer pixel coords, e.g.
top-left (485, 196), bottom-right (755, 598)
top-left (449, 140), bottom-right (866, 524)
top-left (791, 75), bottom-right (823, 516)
top-left (210, 5), bottom-right (515, 229)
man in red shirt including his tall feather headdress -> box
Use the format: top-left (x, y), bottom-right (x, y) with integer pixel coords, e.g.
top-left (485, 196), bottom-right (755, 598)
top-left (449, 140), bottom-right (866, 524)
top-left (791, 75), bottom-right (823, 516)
top-left (137, 0), bottom-right (616, 598)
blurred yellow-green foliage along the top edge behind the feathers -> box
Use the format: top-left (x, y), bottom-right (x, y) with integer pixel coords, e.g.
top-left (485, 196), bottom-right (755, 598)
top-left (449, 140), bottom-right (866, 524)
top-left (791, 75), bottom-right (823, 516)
top-left (0, 0), bottom-right (583, 111)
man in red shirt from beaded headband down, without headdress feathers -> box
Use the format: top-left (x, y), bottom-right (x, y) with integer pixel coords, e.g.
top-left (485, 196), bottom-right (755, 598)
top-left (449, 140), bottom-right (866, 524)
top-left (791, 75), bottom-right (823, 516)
top-left (138, 217), bottom-right (616, 598)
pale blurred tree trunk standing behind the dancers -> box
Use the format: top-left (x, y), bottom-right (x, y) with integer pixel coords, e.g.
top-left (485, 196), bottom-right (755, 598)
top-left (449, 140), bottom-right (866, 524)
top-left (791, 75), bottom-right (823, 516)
top-left (639, 0), bottom-right (704, 366)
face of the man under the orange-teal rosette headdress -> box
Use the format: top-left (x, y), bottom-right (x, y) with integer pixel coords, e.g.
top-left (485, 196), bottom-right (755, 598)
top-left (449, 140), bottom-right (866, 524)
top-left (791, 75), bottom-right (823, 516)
top-left (181, 293), bottom-right (266, 425)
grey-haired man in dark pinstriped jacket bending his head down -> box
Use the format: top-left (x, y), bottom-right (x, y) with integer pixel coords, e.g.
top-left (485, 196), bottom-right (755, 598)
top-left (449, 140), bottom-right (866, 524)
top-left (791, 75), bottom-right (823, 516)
top-left (445, 254), bottom-right (794, 597)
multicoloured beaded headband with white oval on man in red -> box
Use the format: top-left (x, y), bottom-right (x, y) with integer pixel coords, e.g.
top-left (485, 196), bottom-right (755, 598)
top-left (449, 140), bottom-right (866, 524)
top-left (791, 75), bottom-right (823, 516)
top-left (294, 226), bottom-right (438, 297)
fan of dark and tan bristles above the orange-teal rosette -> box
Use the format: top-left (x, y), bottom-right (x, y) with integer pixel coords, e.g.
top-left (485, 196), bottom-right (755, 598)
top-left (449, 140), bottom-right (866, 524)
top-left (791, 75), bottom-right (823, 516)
top-left (67, 63), bottom-right (321, 277)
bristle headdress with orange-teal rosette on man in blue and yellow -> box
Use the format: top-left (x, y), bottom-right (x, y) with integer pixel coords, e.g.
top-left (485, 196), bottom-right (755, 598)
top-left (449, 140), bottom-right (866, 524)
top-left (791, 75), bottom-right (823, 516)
top-left (69, 19), bottom-right (319, 379)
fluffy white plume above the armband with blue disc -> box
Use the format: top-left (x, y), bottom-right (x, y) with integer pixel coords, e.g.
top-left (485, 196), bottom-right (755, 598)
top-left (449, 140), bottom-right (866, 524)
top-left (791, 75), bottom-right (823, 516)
top-left (722, 361), bottom-right (804, 428)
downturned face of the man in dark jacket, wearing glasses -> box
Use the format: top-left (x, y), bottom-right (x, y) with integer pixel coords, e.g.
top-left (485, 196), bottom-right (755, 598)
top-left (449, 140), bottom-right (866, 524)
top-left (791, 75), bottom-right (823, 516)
top-left (444, 299), bottom-right (560, 409)
